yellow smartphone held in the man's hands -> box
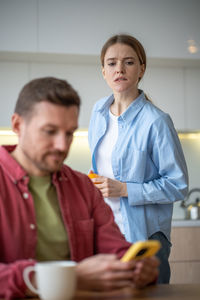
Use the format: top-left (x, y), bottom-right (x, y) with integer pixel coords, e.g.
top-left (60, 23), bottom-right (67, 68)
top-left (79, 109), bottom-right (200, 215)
top-left (121, 240), bottom-right (161, 262)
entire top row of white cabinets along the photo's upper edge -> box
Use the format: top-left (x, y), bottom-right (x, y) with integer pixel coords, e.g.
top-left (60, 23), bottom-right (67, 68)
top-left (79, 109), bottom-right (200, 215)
top-left (0, 0), bottom-right (200, 59)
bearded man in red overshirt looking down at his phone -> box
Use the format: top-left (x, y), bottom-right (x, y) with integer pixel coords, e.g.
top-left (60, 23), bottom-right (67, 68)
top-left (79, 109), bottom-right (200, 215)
top-left (0, 77), bottom-right (158, 299)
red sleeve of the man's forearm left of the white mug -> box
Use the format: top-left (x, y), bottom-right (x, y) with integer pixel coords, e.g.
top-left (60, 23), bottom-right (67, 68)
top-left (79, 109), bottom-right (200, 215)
top-left (0, 260), bottom-right (35, 300)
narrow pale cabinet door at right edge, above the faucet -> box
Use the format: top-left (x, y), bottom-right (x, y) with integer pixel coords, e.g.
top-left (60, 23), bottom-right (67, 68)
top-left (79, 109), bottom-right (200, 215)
top-left (185, 68), bottom-right (200, 130)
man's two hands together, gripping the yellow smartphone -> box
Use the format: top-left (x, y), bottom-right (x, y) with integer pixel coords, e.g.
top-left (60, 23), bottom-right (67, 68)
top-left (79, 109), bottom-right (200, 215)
top-left (76, 254), bottom-right (159, 291)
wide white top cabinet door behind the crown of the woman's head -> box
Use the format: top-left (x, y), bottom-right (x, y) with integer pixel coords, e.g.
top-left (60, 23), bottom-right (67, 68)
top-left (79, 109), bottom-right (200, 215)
top-left (38, 0), bottom-right (200, 59)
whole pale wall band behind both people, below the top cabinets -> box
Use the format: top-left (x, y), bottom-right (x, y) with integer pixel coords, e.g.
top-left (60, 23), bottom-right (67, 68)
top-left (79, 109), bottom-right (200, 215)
top-left (0, 53), bottom-right (200, 131)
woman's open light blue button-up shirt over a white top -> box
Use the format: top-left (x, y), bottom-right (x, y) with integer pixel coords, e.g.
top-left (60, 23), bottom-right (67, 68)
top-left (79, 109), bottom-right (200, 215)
top-left (88, 92), bottom-right (188, 242)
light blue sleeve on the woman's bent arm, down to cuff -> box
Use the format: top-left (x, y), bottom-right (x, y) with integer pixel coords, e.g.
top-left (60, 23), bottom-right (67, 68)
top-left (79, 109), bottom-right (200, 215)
top-left (127, 114), bottom-right (188, 205)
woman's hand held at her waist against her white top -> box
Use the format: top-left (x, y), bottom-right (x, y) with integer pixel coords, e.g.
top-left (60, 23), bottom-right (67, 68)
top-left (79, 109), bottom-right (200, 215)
top-left (91, 176), bottom-right (128, 198)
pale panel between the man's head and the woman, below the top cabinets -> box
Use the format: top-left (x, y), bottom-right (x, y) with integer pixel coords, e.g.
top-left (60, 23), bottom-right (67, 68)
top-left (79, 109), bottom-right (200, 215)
top-left (30, 63), bottom-right (111, 127)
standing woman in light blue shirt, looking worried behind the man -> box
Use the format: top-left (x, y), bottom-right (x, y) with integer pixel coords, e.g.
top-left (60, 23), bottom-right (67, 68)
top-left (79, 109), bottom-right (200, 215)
top-left (89, 35), bottom-right (188, 283)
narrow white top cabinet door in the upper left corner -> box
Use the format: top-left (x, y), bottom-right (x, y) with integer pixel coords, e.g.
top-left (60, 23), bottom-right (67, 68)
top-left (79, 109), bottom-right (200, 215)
top-left (0, 0), bottom-right (38, 52)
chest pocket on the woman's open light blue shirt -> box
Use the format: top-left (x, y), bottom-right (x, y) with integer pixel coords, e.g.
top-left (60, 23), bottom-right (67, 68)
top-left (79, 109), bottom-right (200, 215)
top-left (120, 147), bottom-right (148, 183)
